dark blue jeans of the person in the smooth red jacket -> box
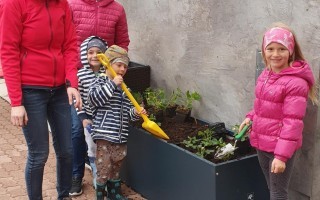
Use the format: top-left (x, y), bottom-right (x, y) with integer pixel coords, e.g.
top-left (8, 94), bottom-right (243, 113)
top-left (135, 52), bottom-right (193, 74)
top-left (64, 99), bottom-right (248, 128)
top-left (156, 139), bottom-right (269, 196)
top-left (22, 86), bottom-right (73, 200)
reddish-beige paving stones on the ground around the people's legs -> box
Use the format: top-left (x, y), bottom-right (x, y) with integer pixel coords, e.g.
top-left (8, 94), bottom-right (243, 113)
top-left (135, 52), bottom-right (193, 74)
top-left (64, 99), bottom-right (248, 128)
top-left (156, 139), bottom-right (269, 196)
top-left (0, 97), bottom-right (145, 200)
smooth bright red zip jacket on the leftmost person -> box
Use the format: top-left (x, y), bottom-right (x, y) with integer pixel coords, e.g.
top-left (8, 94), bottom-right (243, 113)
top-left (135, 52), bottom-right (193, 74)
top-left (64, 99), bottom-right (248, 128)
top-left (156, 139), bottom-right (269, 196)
top-left (0, 0), bottom-right (78, 106)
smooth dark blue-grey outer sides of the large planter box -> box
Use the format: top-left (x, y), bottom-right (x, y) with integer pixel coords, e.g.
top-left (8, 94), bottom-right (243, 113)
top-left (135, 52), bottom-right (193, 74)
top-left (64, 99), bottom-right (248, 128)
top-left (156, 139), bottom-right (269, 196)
top-left (121, 127), bottom-right (269, 200)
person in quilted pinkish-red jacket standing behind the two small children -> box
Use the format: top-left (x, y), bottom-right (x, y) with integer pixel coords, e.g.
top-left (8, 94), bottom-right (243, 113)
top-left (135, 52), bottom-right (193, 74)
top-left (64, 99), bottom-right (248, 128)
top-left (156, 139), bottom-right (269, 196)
top-left (68, 0), bottom-right (130, 196)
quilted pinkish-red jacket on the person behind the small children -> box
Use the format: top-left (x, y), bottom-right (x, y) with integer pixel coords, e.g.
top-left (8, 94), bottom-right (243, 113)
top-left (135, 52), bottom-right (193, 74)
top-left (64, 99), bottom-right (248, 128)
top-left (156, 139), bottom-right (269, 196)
top-left (68, 0), bottom-right (130, 50)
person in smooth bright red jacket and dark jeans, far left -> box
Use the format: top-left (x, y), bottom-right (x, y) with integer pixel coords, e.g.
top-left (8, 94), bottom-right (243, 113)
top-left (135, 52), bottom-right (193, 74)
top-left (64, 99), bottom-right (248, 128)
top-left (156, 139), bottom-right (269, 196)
top-left (0, 0), bottom-right (81, 200)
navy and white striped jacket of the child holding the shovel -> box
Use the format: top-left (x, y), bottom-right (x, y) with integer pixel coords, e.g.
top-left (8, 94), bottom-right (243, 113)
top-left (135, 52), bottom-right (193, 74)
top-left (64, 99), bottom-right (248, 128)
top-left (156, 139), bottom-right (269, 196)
top-left (88, 72), bottom-right (139, 143)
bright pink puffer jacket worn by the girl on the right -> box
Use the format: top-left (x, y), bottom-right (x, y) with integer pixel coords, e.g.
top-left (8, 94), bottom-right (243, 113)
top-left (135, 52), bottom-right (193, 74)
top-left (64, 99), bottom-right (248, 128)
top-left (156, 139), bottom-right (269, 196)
top-left (247, 61), bottom-right (314, 162)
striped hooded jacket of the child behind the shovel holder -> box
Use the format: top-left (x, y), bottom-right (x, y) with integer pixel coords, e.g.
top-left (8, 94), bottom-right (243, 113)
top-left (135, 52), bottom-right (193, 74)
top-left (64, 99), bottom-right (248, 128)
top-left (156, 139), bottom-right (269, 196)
top-left (78, 36), bottom-right (108, 121)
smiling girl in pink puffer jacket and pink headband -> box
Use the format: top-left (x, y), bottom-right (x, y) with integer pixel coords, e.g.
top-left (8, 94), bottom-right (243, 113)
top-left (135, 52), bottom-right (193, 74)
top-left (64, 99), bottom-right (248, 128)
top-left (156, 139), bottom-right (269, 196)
top-left (240, 23), bottom-right (318, 200)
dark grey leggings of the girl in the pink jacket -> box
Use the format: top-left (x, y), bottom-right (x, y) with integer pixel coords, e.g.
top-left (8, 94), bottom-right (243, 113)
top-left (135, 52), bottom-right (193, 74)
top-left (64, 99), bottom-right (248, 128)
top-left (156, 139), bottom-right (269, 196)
top-left (257, 150), bottom-right (295, 200)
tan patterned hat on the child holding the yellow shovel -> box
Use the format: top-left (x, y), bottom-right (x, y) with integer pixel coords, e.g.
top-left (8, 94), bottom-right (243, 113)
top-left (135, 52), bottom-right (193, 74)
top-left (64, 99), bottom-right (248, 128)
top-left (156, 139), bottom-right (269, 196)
top-left (105, 45), bottom-right (130, 66)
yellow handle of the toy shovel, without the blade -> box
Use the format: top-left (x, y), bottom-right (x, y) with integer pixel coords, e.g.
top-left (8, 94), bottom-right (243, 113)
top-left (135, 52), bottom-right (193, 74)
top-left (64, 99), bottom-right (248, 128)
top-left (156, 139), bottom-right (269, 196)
top-left (97, 53), bottom-right (149, 121)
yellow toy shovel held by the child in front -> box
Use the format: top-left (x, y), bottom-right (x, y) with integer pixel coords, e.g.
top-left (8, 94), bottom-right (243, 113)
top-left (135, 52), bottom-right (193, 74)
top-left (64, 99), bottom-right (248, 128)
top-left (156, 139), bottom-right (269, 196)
top-left (97, 53), bottom-right (169, 140)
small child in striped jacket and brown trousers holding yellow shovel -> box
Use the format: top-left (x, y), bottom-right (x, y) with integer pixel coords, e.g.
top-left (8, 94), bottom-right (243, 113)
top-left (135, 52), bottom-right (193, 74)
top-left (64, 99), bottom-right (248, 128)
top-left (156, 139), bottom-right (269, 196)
top-left (88, 45), bottom-right (146, 200)
